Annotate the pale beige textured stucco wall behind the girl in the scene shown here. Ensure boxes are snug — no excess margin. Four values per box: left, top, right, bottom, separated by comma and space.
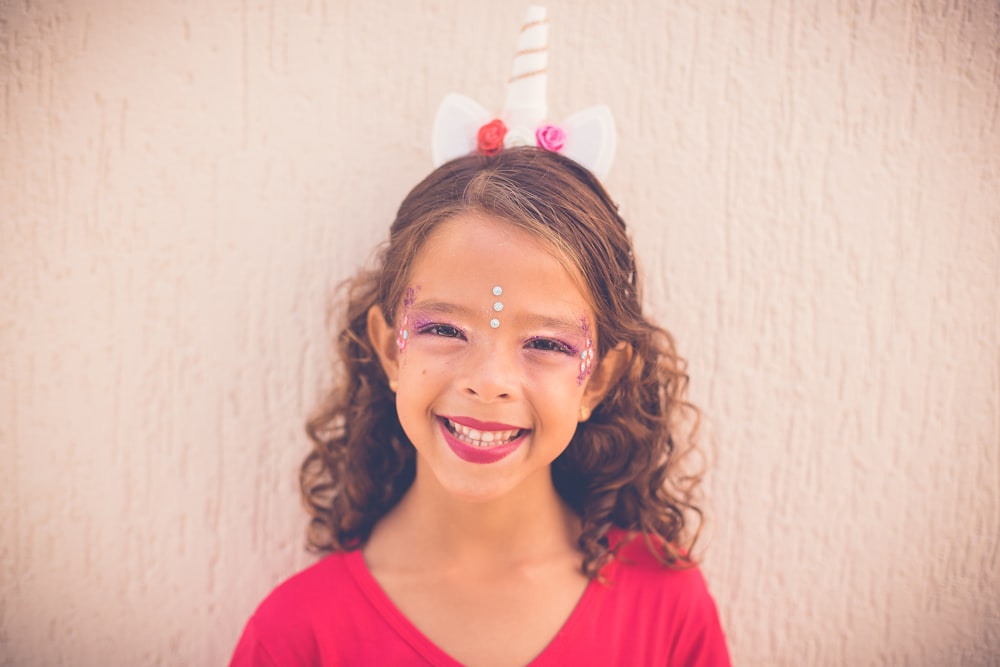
0, 0, 1000, 666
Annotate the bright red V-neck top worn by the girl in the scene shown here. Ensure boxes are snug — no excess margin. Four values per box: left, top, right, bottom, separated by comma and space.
230, 536, 729, 667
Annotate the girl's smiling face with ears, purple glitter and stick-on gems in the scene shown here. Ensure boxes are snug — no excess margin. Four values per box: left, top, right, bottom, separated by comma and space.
369, 213, 605, 500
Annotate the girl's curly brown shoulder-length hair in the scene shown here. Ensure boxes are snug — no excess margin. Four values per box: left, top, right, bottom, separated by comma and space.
299, 147, 702, 577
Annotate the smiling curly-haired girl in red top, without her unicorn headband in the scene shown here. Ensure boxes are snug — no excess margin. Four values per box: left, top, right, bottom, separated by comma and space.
232, 146, 729, 667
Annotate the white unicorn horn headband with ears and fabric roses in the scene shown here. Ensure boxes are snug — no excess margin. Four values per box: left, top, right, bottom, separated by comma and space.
431, 6, 615, 178
